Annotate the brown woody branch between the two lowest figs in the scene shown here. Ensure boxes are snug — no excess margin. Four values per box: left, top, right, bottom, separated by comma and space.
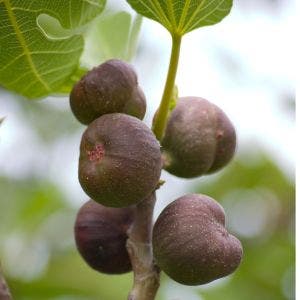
126, 192, 160, 300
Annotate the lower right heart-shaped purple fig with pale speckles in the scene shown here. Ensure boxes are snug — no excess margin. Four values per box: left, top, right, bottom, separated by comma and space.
153, 194, 243, 285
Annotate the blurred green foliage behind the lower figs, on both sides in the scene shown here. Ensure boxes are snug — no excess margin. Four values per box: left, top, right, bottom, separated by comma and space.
0, 153, 295, 300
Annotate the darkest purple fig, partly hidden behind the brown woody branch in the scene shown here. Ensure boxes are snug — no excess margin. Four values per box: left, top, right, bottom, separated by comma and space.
74, 200, 134, 274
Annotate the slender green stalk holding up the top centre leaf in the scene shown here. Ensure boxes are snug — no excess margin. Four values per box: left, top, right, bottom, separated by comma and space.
152, 34, 181, 141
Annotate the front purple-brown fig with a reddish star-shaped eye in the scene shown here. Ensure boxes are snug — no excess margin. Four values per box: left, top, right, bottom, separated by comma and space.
79, 113, 161, 207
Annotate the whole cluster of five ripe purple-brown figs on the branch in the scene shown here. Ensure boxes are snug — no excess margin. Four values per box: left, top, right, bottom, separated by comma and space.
70, 59, 243, 285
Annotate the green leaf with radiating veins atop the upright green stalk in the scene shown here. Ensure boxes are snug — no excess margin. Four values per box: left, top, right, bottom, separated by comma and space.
127, 0, 232, 36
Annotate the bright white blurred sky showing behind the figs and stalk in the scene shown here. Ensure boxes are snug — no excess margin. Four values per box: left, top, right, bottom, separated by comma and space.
0, 0, 296, 203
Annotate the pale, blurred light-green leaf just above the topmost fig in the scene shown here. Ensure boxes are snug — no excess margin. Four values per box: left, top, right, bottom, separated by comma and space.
82, 11, 142, 66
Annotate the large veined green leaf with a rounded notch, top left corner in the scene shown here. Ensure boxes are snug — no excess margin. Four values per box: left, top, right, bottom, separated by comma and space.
0, 0, 105, 98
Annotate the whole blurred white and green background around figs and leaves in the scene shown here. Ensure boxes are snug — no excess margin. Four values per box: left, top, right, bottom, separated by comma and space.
0, 0, 296, 300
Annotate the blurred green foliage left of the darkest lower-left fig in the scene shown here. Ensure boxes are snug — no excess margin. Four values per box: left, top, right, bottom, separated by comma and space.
0, 177, 131, 300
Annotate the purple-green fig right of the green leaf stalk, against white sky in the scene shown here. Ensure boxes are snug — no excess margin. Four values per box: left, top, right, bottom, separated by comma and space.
161, 97, 236, 178
